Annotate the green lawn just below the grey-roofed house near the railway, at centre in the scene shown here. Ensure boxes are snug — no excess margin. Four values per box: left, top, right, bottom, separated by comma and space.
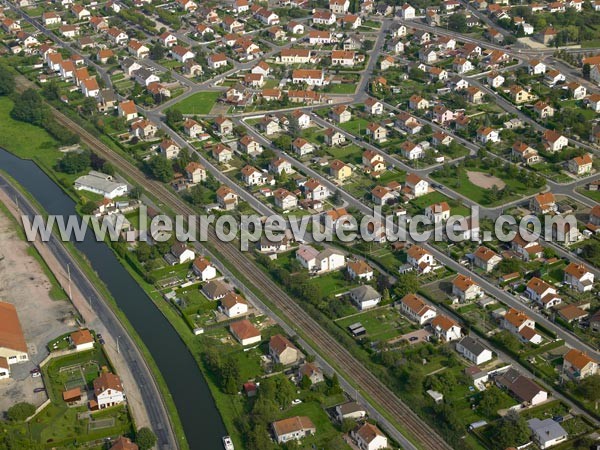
336, 306, 410, 341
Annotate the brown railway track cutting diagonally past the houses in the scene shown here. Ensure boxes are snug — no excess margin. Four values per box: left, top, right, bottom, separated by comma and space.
52, 109, 451, 450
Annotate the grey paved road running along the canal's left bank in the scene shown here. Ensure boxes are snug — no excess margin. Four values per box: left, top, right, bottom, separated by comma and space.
0, 175, 179, 450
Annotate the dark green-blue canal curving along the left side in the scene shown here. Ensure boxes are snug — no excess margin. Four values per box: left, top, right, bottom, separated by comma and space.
0, 149, 227, 450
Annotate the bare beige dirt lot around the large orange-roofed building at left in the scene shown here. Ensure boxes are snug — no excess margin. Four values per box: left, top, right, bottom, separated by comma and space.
0, 206, 76, 414
